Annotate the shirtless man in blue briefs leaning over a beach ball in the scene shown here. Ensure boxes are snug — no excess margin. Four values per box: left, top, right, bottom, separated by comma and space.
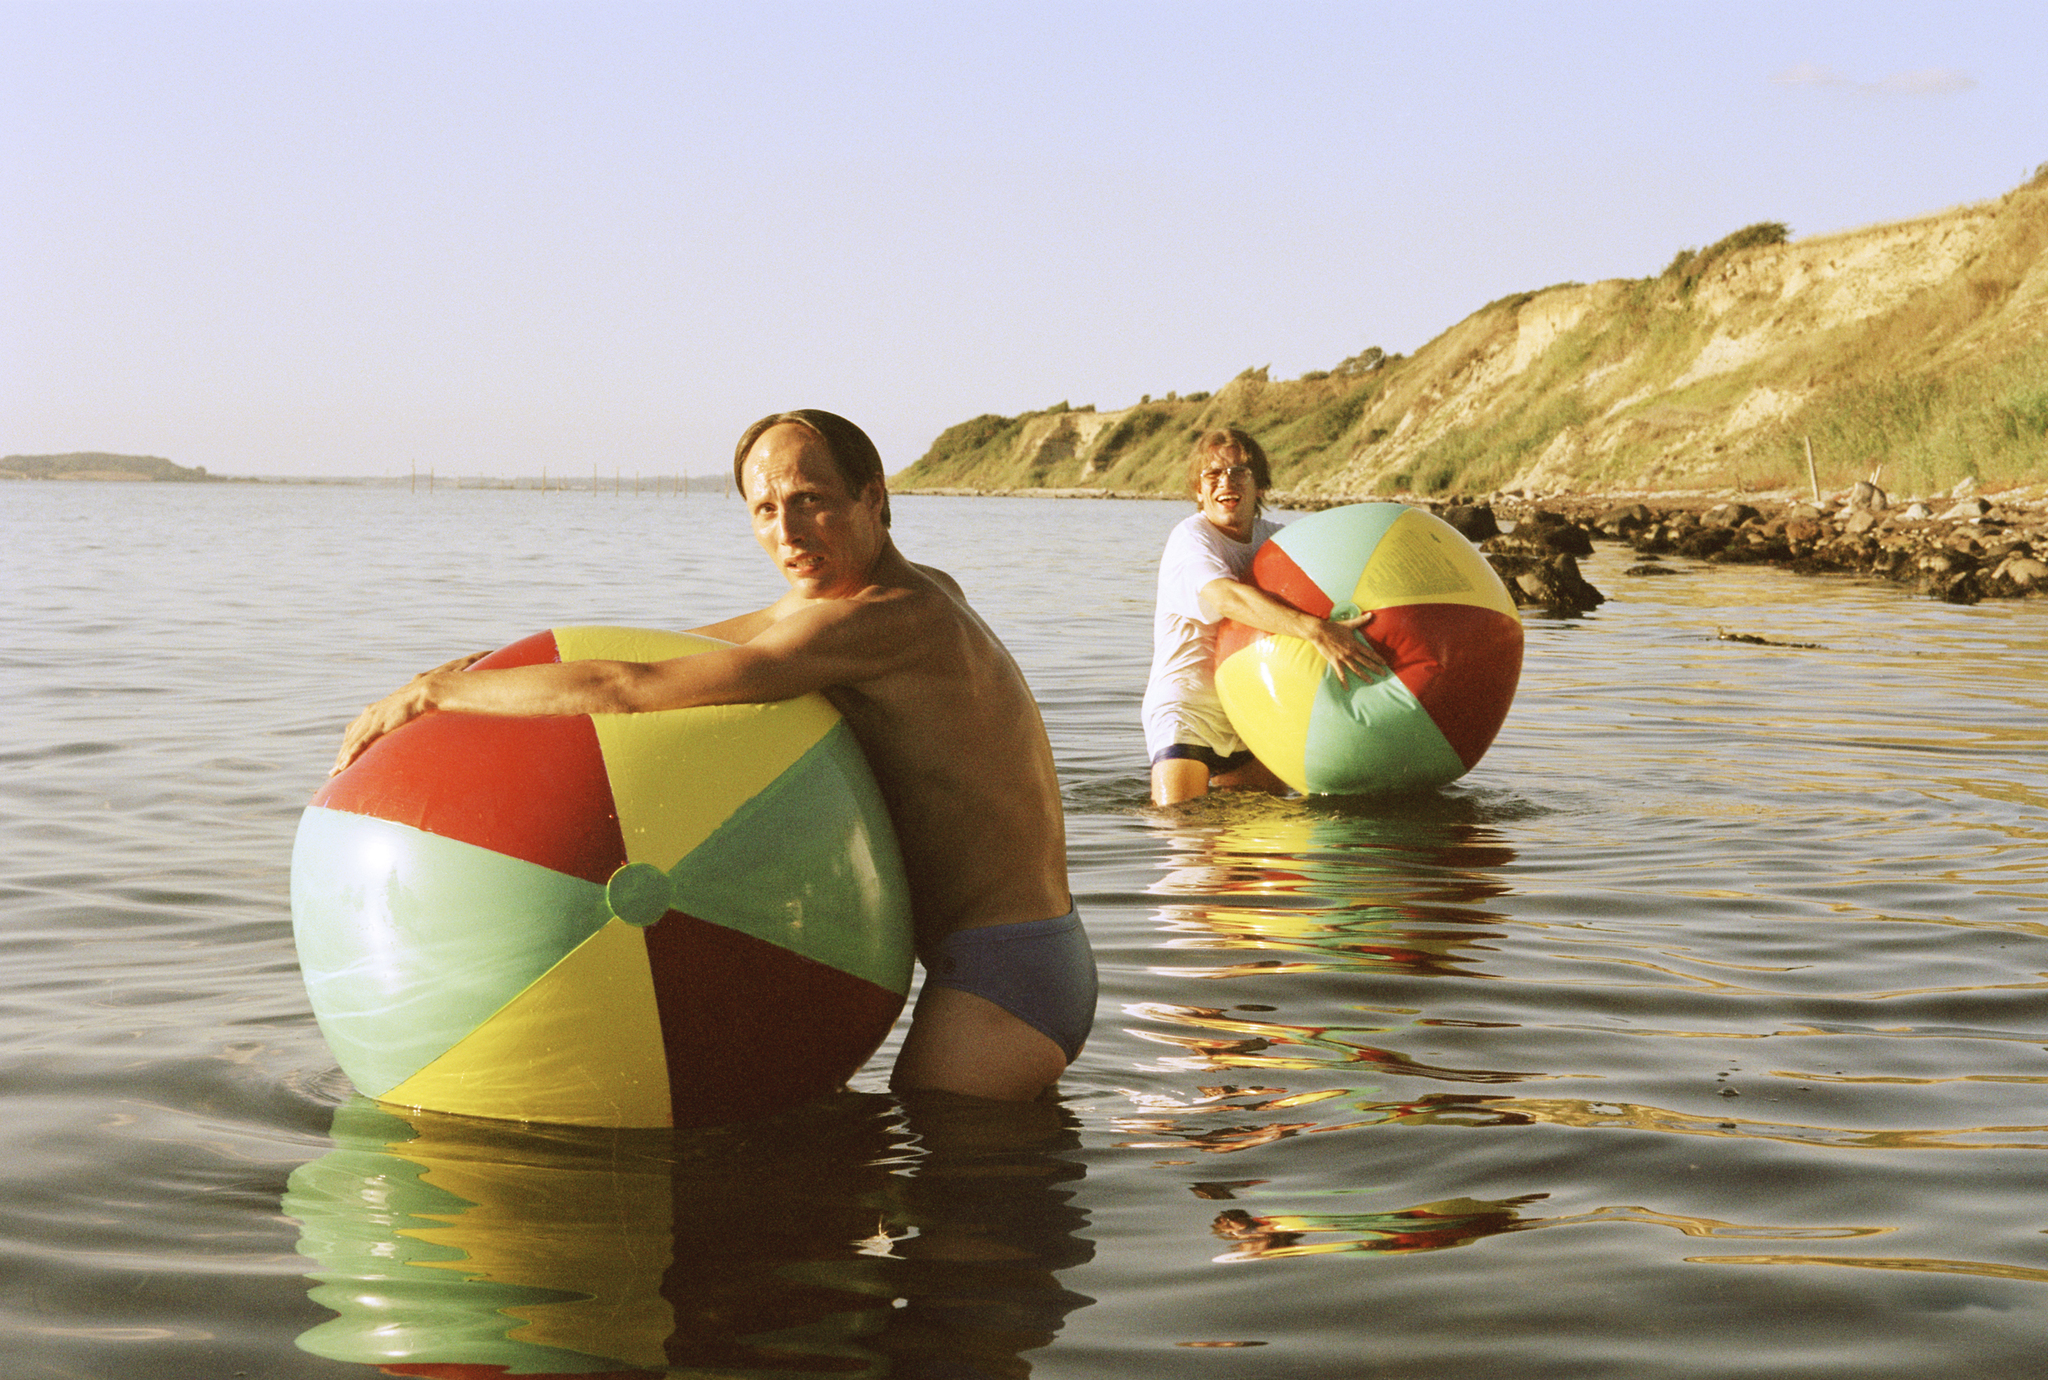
334, 409, 1096, 1102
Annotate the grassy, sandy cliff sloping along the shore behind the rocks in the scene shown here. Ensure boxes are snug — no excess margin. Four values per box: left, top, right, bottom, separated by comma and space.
895, 164, 2048, 498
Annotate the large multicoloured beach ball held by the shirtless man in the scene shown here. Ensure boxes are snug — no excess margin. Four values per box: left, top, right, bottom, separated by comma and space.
291, 629, 911, 1126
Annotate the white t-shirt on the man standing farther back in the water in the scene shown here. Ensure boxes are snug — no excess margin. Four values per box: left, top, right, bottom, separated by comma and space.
1145, 514, 1280, 758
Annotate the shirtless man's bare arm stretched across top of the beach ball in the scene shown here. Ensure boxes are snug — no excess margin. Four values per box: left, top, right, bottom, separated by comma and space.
334, 598, 918, 772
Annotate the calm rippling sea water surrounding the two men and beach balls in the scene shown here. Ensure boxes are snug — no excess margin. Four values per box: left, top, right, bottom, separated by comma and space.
0, 483, 2048, 1380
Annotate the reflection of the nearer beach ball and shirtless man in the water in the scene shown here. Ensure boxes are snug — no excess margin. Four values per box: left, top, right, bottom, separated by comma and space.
283, 1093, 1092, 1378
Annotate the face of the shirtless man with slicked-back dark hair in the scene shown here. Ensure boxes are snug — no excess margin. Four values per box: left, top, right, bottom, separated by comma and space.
739, 422, 887, 600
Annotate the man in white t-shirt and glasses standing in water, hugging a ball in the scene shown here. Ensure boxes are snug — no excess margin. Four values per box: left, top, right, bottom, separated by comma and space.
1145, 426, 1386, 805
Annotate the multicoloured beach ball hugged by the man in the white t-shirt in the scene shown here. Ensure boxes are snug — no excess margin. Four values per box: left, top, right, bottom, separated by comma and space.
1217, 504, 1522, 794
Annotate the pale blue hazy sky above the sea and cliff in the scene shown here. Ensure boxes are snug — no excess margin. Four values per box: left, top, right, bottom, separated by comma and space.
0, 0, 2048, 475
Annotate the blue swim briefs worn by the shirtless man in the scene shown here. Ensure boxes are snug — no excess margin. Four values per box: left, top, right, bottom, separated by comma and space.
920, 909, 1096, 1063
